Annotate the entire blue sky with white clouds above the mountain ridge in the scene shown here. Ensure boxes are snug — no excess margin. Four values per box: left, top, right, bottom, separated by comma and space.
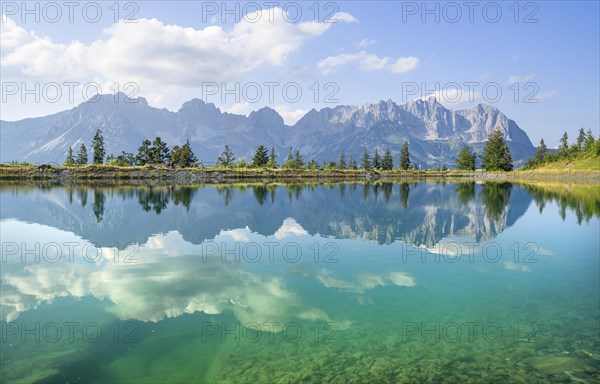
1, 1, 600, 146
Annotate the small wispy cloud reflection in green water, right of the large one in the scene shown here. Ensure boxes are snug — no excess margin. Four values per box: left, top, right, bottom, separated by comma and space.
315, 269, 416, 293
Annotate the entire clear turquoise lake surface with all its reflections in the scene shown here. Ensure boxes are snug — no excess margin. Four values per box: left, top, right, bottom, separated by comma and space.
0, 183, 600, 383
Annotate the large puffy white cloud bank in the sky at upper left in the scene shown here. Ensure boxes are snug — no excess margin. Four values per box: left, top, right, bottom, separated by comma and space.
1, 10, 356, 86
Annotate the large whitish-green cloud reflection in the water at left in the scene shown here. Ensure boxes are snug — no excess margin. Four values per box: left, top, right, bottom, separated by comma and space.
0, 232, 331, 323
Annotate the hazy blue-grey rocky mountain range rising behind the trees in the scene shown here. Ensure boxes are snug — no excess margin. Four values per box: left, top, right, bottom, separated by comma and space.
0, 94, 534, 167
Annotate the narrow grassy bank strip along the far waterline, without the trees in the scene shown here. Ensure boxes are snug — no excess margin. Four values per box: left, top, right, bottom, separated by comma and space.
0, 165, 600, 185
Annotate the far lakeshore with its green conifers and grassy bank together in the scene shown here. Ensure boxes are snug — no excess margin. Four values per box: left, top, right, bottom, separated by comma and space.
0, 125, 600, 183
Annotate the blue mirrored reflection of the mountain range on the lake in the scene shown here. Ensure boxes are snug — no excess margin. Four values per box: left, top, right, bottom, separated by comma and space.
1, 183, 532, 247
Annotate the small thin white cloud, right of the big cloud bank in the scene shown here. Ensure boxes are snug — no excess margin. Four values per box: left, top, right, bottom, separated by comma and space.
317, 51, 419, 75
